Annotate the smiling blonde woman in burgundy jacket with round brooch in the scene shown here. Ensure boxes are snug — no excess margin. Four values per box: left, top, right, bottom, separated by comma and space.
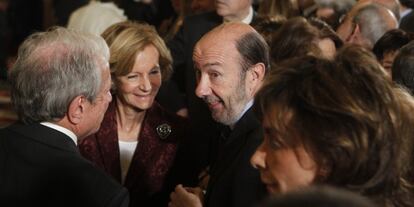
79, 22, 185, 206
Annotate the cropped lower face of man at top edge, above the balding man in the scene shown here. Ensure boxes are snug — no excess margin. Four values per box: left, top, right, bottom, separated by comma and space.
214, 0, 251, 19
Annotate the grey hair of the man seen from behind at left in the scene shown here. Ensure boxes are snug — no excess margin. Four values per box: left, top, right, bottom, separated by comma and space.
9, 27, 109, 123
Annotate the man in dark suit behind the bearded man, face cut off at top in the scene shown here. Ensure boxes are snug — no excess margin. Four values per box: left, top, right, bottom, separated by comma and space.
167, 0, 255, 187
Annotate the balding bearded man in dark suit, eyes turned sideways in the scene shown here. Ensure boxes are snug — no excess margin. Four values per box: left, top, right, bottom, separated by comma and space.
170, 23, 269, 207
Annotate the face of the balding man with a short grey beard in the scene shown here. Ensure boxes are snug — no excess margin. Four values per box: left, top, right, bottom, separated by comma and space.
193, 37, 251, 125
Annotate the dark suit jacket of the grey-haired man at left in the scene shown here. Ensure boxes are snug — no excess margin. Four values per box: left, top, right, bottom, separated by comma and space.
0, 123, 128, 207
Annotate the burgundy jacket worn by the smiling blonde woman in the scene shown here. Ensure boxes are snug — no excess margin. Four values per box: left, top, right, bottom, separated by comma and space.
79, 99, 186, 206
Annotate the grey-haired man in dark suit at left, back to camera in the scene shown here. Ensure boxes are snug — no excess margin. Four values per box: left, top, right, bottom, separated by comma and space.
0, 28, 129, 206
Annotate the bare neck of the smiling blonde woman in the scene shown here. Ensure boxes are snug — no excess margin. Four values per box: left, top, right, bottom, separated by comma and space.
116, 100, 146, 132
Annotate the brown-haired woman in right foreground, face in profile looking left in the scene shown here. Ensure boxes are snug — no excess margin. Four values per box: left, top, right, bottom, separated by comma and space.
251, 46, 414, 207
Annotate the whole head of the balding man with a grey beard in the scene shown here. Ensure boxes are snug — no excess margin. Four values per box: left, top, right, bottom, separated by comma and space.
193, 23, 269, 125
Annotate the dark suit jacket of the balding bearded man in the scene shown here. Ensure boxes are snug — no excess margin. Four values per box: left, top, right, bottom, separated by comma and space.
204, 109, 267, 207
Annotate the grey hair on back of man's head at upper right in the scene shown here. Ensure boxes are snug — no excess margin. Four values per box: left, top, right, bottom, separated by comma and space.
353, 3, 395, 47
